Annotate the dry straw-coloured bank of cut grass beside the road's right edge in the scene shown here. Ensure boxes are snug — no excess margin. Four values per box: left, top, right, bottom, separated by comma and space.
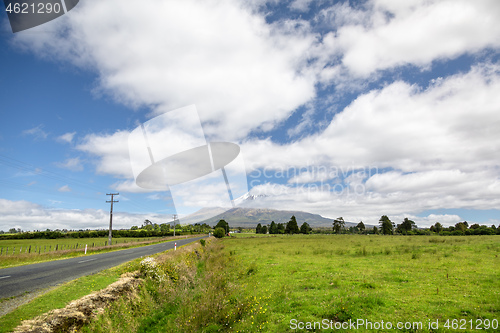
14, 272, 143, 333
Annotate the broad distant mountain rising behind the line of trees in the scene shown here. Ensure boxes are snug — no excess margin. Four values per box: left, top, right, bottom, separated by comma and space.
193, 208, 357, 228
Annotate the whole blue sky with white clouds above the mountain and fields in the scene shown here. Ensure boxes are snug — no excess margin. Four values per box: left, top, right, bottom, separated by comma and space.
0, 0, 500, 231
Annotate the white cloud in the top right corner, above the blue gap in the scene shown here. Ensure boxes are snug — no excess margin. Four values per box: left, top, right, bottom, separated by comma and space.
328, 0, 500, 76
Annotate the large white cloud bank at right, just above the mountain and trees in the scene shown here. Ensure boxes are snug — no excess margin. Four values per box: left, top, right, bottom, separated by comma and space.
243, 65, 500, 220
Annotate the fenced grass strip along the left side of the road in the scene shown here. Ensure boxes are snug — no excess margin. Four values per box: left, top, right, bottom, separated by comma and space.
0, 235, 194, 268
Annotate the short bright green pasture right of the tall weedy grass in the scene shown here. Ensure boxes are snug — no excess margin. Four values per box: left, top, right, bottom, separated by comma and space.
224, 235, 500, 332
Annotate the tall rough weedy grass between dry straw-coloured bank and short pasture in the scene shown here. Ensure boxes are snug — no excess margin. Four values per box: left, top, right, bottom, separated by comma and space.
81, 240, 257, 333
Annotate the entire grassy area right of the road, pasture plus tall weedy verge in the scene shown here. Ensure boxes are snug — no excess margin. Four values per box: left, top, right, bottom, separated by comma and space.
73, 235, 500, 332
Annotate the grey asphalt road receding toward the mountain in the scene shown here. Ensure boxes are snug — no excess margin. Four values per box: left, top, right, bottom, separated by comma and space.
0, 236, 208, 298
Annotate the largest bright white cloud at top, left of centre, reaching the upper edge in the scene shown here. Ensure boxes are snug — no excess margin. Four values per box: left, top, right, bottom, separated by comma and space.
16, 0, 316, 140
